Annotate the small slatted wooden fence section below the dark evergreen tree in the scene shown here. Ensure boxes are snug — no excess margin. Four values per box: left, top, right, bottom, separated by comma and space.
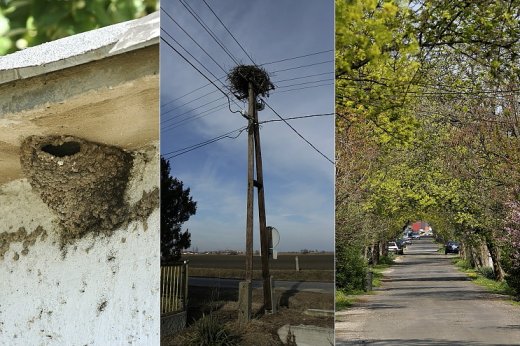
161, 261, 188, 315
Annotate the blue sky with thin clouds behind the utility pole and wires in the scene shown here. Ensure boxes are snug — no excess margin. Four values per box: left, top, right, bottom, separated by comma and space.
160, 0, 334, 251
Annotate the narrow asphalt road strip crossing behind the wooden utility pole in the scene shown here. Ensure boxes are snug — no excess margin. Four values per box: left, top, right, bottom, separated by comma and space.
188, 277, 334, 294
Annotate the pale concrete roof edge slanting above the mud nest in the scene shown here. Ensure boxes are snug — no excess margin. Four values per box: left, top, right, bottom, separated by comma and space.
0, 11, 160, 84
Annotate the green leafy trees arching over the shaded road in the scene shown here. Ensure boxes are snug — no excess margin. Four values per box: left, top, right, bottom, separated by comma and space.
336, 0, 520, 293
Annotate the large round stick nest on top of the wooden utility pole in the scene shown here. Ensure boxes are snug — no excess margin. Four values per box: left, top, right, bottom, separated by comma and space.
227, 65, 274, 100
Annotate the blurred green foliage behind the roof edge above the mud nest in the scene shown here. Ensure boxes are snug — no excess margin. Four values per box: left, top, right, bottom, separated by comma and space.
0, 0, 159, 55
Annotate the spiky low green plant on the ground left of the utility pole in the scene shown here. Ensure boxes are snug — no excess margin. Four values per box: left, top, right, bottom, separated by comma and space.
191, 313, 240, 346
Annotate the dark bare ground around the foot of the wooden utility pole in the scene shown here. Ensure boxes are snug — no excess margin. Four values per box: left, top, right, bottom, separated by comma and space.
161, 287, 334, 346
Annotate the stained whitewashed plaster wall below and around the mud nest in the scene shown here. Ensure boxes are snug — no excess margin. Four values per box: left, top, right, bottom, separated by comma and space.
0, 143, 160, 345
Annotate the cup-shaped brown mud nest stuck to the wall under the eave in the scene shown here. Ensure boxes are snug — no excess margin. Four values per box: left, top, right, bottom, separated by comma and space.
20, 136, 132, 244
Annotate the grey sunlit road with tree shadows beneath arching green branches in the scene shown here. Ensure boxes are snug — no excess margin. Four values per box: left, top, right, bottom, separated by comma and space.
335, 239, 520, 346
